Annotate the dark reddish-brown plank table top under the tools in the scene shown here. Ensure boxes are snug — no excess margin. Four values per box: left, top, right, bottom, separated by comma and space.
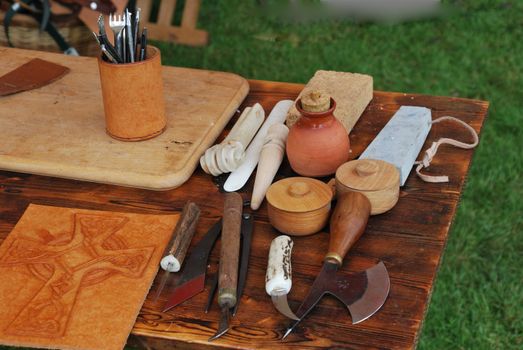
0, 80, 488, 349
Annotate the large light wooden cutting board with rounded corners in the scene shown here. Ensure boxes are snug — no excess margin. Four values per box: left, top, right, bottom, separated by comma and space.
0, 48, 249, 190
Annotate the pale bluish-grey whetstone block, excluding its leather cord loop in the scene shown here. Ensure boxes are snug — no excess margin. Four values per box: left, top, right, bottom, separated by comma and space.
359, 106, 432, 186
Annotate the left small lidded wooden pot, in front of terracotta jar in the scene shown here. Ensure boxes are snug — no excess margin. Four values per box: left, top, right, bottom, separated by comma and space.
266, 177, 333, 236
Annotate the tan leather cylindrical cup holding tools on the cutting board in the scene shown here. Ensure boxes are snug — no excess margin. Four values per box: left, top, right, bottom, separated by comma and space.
98, 46, 166, 141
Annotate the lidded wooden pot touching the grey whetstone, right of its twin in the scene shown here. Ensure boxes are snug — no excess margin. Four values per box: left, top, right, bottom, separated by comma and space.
336, 159, 400, 215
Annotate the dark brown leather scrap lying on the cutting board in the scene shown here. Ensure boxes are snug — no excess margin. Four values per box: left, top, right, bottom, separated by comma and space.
0, 58, 69, 96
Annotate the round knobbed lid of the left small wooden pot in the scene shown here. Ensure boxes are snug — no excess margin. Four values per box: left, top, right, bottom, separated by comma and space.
266, 177, 333, 213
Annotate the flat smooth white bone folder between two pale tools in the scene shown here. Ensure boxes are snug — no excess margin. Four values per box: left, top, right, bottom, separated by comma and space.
223, 100, 294, 192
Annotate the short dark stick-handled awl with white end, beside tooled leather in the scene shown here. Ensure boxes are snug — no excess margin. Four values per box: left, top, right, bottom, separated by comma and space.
155, 202, 200, 300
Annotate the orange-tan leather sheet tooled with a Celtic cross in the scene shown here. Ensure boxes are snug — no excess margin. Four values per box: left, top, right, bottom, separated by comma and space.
0, 205, 179, 349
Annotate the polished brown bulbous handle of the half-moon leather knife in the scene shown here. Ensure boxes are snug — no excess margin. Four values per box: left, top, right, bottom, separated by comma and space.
325, 191, 370, 265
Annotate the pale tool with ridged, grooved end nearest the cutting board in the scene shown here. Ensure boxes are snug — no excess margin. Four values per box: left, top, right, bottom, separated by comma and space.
200, 103, 265, 176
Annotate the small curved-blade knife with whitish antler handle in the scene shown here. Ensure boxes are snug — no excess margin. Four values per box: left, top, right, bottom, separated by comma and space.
265, 235, 299, 320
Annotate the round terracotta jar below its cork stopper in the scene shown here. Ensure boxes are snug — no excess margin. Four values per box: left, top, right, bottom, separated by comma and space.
286, 98, 350, 177
